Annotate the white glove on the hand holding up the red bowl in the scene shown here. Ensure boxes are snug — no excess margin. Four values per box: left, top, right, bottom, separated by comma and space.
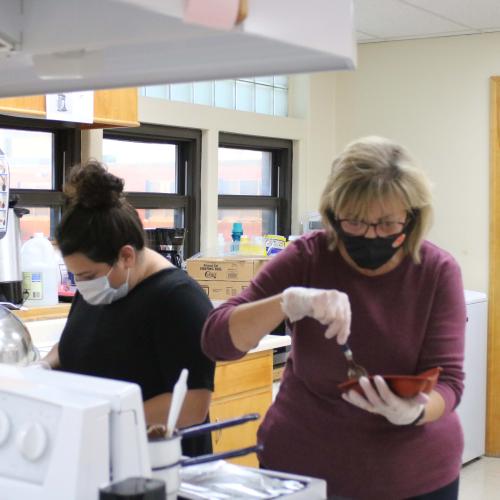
342, 375, 429, 425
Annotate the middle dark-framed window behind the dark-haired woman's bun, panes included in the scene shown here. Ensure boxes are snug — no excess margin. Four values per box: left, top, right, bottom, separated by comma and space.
103, 125, 201, 258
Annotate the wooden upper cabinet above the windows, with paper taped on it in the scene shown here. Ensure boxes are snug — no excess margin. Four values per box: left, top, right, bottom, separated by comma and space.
0, 88, 140, 128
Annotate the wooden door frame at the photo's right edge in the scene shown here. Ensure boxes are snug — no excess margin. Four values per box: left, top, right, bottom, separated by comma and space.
486, 76, 500, 456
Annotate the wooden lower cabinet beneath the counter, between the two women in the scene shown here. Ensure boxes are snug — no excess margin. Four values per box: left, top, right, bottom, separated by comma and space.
210, 349, 273, 467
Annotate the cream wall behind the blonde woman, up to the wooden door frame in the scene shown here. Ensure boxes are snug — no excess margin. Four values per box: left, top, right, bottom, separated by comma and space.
335, 34, 500, 292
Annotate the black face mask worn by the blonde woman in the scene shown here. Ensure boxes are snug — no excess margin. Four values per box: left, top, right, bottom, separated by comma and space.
327, 208, 415, 270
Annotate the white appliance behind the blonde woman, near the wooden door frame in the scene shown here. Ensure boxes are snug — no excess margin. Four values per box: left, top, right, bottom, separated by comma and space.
457, 290, 488, 463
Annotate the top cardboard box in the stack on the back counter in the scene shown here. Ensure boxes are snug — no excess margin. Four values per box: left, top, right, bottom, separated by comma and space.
186, 257, 269, 281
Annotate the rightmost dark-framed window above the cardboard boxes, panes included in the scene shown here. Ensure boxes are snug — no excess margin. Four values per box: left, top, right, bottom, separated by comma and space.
217, 133, 292, 241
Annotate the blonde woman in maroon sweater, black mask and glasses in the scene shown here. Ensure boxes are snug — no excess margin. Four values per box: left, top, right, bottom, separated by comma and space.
202, 137, 465, 500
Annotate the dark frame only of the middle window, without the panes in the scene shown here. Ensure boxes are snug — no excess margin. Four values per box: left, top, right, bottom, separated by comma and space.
103, 123, 201, 259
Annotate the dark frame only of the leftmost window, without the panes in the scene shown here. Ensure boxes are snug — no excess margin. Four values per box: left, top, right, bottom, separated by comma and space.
0, 115, 81, 237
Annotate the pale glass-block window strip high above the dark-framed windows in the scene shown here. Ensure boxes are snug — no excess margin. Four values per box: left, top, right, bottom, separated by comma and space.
141, 76, 288, 116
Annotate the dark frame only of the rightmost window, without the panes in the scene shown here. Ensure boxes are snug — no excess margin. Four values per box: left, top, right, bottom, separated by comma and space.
218, 132, 293, 238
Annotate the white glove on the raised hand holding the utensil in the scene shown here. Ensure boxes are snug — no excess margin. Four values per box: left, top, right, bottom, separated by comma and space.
281, 286, 351, 344
